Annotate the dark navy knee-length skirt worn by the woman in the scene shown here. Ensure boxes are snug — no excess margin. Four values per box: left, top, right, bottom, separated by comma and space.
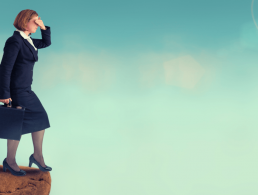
5, 86, 50, 135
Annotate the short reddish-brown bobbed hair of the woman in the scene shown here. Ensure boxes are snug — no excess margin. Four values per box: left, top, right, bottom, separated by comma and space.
13, 9, 38, 34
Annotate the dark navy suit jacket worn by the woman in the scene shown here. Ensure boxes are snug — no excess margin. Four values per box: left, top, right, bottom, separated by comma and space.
0, 26, 51, 99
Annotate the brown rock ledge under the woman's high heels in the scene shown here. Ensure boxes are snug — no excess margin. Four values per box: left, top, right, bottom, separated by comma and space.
0, 165, 51, 195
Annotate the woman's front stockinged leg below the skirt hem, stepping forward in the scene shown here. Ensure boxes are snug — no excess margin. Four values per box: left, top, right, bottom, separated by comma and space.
31, 129, 46, 167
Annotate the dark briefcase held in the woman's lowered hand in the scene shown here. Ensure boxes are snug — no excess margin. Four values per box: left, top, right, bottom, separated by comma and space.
0, 101, 26, 141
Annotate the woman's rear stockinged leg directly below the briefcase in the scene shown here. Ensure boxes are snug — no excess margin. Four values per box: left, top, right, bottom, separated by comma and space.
6, 136, 20, 171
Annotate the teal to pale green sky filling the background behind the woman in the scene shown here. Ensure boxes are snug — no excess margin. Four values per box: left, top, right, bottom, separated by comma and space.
0, 0, 258, 195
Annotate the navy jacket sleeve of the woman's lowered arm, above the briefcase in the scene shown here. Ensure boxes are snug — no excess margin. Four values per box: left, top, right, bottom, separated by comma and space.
0, 37, 20, 99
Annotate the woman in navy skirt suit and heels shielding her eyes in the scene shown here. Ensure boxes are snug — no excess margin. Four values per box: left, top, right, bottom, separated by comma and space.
0, 9, 52, 176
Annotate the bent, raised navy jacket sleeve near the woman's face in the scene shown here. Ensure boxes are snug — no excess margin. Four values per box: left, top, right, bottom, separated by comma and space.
31, 26, 51, 49
